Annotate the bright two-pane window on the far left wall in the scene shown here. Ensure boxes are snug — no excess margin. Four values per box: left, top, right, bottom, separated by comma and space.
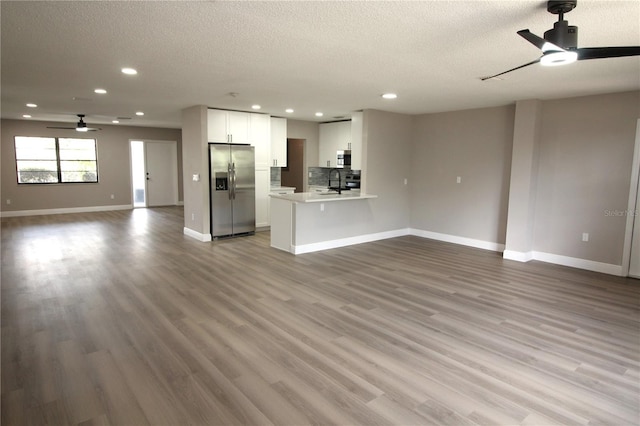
15, 136, 98, 183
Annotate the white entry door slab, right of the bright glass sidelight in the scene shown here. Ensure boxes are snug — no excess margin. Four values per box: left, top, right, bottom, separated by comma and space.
145, 141, 178, 207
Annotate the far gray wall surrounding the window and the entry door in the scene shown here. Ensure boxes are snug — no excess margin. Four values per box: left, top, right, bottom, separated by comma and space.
0, 120, 183, 212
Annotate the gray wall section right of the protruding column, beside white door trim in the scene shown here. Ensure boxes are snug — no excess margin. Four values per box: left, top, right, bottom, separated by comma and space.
534, 92, 640, 265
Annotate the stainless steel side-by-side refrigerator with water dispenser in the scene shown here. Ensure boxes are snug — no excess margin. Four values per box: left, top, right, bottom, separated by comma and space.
209, 144, 256, 238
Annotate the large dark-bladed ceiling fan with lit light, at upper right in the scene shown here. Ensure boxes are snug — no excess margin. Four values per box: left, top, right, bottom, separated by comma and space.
480, 0, 640, 81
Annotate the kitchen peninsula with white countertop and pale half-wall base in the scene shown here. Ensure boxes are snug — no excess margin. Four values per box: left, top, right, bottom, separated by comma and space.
271, 191, 377, 254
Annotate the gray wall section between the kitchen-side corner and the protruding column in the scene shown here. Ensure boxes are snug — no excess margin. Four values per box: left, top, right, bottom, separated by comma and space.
410, 106, 515, 244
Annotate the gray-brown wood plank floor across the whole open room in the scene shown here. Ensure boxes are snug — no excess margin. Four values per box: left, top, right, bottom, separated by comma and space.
1, 207, 640, 425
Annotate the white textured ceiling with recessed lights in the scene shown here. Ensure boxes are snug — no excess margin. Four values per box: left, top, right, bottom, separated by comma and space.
0, 0, 640, 128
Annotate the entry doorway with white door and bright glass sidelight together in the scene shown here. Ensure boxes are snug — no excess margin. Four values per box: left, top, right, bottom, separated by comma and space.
130, 140, 178, 208
